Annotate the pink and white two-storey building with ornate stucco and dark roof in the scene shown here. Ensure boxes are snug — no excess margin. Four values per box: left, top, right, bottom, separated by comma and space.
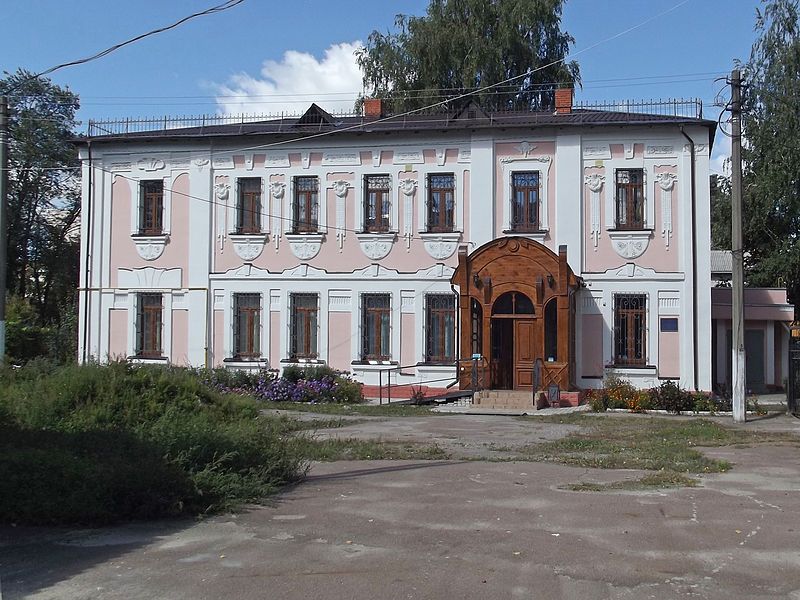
79, 96, 732, 390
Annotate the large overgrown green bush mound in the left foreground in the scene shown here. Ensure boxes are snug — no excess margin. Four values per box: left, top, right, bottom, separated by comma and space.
0, 361, 305, 523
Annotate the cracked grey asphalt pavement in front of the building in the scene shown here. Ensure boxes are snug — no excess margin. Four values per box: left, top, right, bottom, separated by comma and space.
0, 416, 800, 600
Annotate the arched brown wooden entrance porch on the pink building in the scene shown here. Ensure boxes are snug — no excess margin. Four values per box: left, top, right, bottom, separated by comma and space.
451, 237, 579, 390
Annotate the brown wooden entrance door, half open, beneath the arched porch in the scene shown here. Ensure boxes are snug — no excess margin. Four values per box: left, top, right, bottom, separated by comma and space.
491, 316, 540, 390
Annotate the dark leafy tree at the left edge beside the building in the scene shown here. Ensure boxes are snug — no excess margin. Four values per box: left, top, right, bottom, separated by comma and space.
0, 69, 80, 323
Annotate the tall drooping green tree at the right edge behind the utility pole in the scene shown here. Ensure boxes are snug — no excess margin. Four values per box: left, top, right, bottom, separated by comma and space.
742, 0, 800, 306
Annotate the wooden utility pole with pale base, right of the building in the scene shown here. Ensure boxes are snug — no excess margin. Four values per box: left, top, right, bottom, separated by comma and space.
731, 69, 746, 423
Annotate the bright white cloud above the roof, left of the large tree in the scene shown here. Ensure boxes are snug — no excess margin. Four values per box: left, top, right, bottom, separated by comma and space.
215, 41, 361, 115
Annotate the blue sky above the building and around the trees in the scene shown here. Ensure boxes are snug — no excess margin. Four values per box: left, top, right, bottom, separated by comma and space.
0, 0, 761, 166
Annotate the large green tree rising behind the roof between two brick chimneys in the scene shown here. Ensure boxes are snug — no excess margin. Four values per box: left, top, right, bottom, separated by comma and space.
357, 0, 580, 111
